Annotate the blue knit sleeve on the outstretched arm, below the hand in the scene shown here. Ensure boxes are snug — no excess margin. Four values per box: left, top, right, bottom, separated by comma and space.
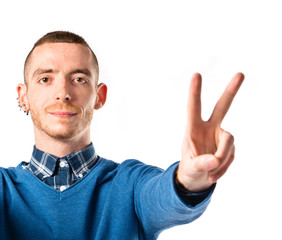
134, 162, 214, 239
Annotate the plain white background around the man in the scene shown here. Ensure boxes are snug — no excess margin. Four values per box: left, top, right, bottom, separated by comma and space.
0, 0, 282, 240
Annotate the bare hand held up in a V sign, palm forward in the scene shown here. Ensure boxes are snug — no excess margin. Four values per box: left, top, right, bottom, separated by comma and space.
177, 73, 244, 192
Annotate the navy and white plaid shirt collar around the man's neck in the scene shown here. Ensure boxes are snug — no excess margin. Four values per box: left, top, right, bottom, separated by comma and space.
26, 143, 97, 180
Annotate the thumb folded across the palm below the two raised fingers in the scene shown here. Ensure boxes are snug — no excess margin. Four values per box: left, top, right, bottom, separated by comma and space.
192, 154, 220, 173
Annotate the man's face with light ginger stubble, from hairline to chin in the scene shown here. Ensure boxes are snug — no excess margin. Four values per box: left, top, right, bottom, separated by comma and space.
23, 43, 102, 139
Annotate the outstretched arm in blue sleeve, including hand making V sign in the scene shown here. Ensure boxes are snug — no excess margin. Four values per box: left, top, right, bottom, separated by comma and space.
135, 73, 244, 237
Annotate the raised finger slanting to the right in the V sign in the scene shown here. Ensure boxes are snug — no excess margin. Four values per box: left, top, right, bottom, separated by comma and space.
210, 73, 245, 123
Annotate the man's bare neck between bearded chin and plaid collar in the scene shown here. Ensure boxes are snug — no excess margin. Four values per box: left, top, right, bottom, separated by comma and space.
34, 127, 90, 158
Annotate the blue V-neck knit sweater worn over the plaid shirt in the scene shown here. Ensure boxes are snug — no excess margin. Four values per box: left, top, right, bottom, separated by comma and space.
0, 158, 211, 240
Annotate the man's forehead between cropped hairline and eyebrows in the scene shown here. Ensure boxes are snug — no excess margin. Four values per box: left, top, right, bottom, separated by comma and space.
28, 43, 96, 77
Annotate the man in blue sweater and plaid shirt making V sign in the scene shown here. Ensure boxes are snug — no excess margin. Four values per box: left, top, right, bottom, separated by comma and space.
0, 32, 244, 240
